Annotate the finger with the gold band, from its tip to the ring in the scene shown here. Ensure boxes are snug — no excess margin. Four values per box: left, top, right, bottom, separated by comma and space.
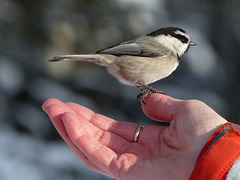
66, 103, 139, 142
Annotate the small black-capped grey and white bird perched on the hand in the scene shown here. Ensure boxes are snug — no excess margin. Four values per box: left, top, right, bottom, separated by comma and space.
49, 27, 196, 103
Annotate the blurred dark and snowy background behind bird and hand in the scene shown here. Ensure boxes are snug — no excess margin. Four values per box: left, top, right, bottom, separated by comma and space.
0, 0, 240, 180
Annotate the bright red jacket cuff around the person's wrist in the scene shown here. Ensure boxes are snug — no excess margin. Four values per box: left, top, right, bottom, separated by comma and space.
189, 122, 240, 180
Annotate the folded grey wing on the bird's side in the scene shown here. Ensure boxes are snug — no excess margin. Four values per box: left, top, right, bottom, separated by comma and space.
96, 41, 167, 57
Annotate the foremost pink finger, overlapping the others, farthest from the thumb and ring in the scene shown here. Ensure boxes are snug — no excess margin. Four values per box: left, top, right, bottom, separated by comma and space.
62, 113, 117, 174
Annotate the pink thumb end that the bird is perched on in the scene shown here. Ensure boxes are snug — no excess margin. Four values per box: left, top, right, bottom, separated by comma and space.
142, 93, 182, 122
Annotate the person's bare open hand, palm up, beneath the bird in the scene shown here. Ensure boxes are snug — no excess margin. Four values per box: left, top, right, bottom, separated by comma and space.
43, 93, 227, 180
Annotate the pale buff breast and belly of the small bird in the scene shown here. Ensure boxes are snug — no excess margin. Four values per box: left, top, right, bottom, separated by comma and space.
108, 54, 179, 86
